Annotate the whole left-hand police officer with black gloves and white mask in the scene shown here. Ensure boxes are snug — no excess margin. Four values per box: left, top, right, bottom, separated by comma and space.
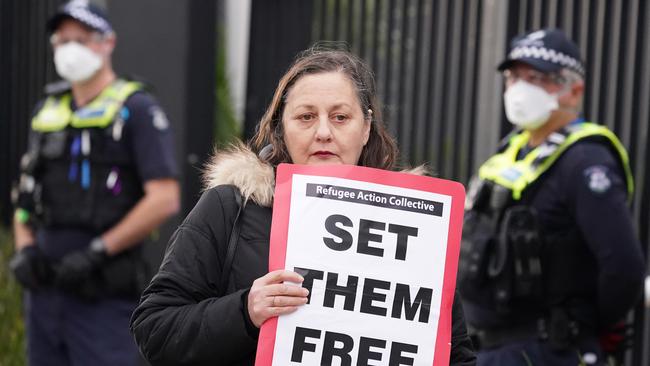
10, 1, 179, 365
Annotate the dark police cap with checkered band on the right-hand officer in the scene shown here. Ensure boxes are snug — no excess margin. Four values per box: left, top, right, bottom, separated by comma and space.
498, 29, 585, 76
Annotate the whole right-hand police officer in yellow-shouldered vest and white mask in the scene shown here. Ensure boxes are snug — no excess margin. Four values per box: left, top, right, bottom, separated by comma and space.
459, 29, 645, 366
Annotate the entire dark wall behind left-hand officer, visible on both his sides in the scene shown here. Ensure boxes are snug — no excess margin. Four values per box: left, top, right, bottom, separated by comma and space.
0, 0, 217, 300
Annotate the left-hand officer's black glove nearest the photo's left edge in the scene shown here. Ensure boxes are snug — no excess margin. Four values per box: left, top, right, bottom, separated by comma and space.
9, 245, 53, 290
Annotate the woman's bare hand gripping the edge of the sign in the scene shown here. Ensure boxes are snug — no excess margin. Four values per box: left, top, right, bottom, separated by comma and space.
248, 269, 309, 328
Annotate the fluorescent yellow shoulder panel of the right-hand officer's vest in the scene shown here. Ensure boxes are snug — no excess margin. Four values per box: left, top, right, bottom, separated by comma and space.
479, 122, 634, 200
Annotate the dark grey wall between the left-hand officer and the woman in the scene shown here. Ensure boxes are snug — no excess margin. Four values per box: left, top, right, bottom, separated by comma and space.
108, 0, 217, 217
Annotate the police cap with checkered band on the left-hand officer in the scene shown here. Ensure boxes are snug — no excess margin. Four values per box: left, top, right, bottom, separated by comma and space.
47, 0, 113, 34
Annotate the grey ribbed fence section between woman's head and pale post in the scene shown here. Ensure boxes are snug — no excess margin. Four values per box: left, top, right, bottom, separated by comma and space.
313, 0, 482, 181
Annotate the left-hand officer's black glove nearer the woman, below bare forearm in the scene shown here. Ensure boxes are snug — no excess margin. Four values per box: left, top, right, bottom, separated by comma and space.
54, 239, 108, 292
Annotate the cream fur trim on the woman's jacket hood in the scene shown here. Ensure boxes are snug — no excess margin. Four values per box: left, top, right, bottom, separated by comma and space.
203, 144, 428, 207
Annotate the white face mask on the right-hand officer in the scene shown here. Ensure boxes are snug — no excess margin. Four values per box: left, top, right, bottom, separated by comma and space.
503, 80, 559, 130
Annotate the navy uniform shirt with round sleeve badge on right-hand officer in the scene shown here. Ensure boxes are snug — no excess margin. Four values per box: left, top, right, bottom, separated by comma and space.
522, 141, 645, 328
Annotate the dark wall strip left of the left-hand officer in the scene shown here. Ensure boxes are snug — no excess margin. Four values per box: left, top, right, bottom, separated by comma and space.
0, 0, 63, 224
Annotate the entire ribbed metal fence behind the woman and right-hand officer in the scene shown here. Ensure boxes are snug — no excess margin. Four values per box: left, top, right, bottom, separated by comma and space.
246, 0, 650, 365
